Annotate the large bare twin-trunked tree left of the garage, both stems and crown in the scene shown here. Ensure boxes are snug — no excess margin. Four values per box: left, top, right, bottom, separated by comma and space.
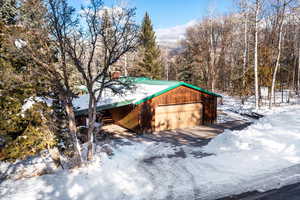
18, 0, 138, 162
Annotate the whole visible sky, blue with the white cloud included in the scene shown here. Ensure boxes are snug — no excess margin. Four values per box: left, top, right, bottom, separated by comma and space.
71, 0, 234, 46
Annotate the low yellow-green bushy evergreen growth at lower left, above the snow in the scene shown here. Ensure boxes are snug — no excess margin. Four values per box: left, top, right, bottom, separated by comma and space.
0, 103, 57, 161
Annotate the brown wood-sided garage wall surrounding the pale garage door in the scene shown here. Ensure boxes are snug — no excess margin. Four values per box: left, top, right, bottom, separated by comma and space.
109, 86, 217, 133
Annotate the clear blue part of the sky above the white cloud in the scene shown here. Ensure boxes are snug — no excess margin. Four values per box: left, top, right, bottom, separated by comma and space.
71, 0, 233, 29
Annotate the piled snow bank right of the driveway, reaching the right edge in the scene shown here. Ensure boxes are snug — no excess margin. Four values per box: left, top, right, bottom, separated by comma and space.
203, 107, 300, 173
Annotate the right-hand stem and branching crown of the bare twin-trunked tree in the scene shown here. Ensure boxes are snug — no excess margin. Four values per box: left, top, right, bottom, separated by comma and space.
53, 0, 138, 160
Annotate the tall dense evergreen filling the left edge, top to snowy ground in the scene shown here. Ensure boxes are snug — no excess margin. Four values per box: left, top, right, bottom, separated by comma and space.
0, 1, 57, 160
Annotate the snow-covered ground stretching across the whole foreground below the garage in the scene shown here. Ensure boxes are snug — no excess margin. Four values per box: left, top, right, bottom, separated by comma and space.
0, 94, 300, 200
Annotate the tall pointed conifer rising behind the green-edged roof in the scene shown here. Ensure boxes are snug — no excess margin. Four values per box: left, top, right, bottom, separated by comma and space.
137, 13, 163, 79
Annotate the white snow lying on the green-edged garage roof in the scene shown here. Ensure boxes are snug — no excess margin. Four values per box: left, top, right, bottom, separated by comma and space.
73, 83, 170, 114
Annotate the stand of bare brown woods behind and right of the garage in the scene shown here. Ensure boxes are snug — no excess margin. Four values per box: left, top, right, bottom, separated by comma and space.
165, 0, 300, 108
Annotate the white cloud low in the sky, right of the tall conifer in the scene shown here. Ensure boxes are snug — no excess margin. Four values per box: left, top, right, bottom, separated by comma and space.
156, 20, 197, 47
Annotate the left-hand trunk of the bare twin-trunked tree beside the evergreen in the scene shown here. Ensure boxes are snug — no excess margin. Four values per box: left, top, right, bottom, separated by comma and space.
65, 100, 82, 167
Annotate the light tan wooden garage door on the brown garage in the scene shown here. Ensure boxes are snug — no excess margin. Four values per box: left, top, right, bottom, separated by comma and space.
155, 103, 203, 131
